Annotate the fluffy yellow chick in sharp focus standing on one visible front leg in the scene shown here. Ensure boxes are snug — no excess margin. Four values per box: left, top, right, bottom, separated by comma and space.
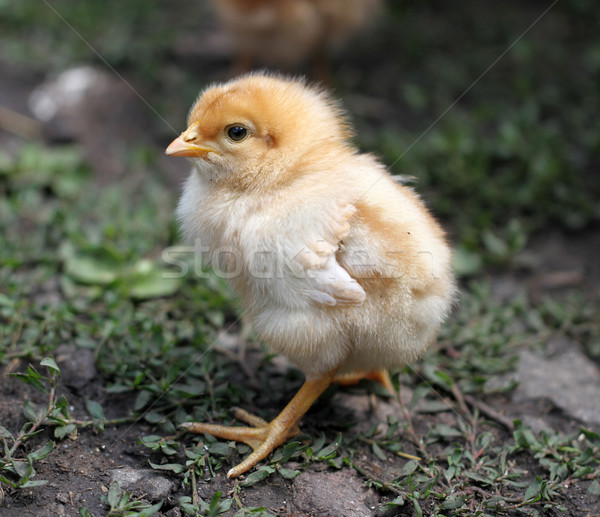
166, 74, 454, 477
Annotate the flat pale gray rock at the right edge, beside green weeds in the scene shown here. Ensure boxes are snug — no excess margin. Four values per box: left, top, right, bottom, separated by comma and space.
513, 345, 600, 425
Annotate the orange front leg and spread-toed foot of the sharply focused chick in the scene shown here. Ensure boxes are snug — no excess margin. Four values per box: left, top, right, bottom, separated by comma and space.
182, 371, 335, 478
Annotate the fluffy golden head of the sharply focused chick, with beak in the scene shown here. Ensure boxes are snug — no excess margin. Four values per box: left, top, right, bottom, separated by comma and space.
166, 74, 351, 189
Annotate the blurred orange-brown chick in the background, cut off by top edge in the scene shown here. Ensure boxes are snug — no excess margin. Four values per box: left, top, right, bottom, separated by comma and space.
213, 0, 381, 79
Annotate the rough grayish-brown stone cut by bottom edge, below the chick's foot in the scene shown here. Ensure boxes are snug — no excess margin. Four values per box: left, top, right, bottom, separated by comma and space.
292, 469, 375, 517
